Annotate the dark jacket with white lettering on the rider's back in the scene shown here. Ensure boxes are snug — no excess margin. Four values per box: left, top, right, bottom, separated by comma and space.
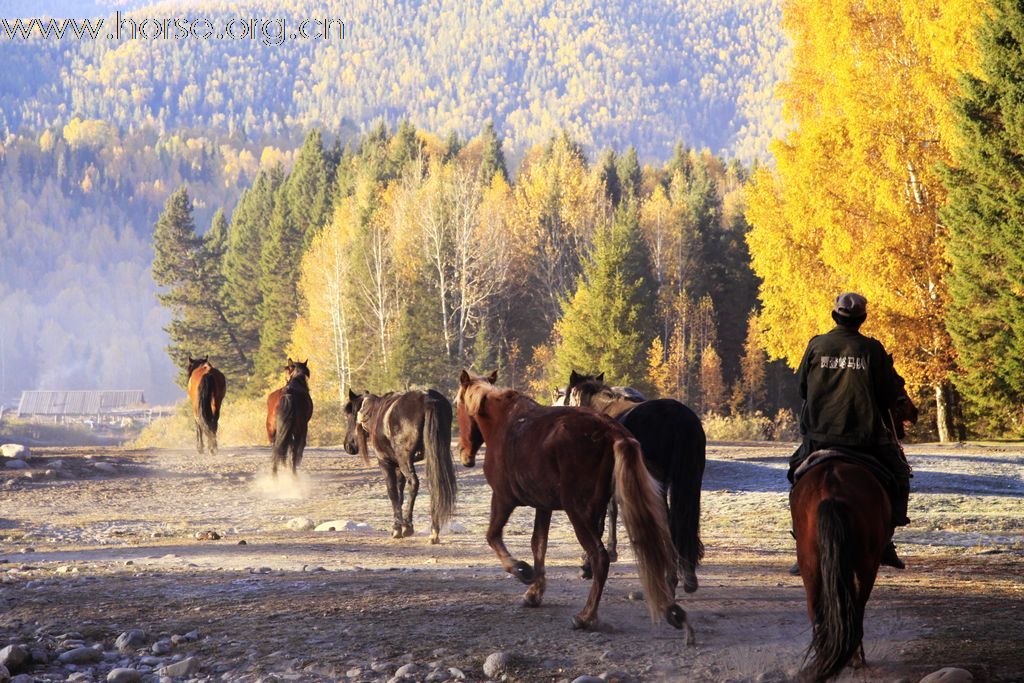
797, 326, 903, 446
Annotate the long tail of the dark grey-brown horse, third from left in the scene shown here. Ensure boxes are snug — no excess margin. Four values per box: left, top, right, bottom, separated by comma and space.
423, 391, 456, 540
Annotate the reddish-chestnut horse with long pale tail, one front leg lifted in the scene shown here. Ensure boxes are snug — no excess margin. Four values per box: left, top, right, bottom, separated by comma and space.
457, 371, 693, 643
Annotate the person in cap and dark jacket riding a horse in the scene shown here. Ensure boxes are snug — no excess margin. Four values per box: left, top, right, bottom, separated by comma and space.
787, 292, 910, 573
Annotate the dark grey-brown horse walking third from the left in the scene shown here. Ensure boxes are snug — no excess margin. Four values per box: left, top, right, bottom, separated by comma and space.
345, 389, 456, 543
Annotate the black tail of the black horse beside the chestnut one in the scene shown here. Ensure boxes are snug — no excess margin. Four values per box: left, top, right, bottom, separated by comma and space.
668, 405, 708, 593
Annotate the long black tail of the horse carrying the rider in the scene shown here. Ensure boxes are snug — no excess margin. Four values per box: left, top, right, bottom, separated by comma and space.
806, 499, 864, 681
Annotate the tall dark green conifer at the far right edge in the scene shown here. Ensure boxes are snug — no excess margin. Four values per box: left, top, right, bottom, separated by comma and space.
942, 0, 1024, 432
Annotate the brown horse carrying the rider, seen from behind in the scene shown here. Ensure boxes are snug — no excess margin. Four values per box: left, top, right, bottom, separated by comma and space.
790, 391, 918, 681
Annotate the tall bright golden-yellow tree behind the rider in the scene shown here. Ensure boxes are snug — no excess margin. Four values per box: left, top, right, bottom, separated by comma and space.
746, 0, 982, 401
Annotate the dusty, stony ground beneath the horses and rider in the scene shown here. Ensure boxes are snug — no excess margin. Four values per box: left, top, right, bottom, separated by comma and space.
0, 443, 1024, 683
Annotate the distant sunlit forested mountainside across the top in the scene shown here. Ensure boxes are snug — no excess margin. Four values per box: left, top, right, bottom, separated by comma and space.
0, 0, 786, 161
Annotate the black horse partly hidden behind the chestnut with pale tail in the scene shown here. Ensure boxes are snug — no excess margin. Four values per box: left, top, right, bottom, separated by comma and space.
565, 371, 707, 593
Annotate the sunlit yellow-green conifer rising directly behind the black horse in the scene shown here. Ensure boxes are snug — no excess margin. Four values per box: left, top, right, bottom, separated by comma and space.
552, 212, 654, 391
